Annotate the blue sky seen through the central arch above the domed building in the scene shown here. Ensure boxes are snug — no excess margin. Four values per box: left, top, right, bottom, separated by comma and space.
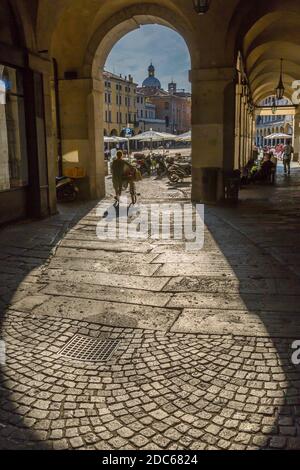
105, 25, 191, 91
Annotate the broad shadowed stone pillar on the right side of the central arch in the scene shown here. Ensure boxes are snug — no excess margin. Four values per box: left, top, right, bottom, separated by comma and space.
191, 67, 236, 203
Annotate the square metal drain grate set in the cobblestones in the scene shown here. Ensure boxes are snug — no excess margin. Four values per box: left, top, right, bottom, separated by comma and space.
59, 335, 120, 362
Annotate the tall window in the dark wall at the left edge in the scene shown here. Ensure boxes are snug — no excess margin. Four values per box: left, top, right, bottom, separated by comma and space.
0, 64, 28, 191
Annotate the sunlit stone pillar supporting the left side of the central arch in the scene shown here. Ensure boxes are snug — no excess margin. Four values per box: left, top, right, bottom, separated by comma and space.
59, 78, 105, 199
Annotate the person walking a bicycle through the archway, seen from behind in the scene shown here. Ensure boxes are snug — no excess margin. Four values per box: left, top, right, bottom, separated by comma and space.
111, 150, 141, 202
